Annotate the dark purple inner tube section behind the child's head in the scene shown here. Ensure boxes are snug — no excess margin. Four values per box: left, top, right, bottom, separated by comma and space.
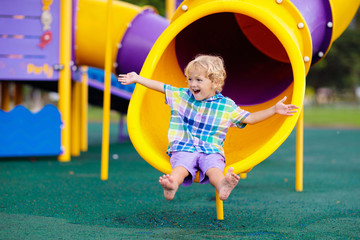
175, 13, 293, 106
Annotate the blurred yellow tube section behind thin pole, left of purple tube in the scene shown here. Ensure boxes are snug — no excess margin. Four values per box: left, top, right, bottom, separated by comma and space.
74, 0, 153, 68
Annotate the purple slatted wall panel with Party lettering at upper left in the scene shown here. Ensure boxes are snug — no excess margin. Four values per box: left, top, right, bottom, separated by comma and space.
0, 0, 60, 81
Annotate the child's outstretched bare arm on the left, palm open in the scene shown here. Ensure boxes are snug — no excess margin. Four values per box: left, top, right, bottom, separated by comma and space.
118, 72, 164, 93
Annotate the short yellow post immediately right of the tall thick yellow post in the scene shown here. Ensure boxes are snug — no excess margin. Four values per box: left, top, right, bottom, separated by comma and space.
71, 81, 81, 156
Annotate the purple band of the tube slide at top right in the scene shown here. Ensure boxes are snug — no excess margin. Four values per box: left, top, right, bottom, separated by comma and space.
291, 0, 333, 64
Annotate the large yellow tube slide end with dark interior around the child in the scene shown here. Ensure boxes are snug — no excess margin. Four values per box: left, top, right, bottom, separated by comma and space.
128, 0, 360, 176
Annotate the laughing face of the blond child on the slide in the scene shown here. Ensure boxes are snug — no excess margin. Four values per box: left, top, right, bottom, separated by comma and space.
187, 68, 216, 101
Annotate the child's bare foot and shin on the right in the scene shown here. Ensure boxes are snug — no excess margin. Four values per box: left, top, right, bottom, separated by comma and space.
206, 167, 240, 200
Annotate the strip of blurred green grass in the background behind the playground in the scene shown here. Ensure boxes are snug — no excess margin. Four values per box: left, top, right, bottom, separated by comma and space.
88, 105, 360, 128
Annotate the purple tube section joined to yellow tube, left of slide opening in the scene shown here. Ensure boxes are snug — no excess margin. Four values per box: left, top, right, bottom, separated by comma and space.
117, 9, 169, 73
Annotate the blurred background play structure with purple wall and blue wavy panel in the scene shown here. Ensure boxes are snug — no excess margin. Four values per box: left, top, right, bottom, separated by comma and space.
0, 0, 168, 161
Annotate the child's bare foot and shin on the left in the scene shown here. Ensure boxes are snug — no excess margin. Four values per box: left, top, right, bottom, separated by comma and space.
159, 166, 189, 200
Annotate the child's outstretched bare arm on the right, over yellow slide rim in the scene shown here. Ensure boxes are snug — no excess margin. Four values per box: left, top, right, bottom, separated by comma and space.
243, 96, 298, 124
